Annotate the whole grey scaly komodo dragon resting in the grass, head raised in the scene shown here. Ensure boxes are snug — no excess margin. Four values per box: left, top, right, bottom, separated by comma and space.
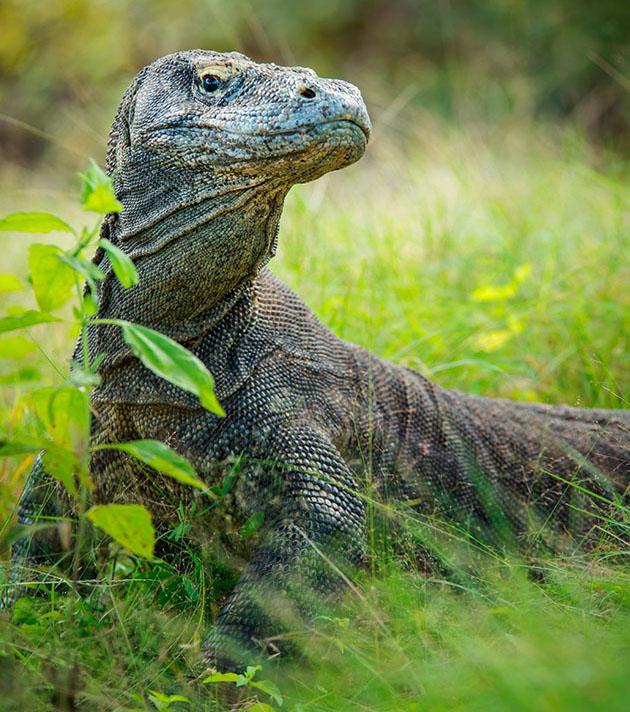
6, 50, 630, 667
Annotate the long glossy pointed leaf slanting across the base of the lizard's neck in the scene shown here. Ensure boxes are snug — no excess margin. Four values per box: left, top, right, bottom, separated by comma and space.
115, 320, 225, 416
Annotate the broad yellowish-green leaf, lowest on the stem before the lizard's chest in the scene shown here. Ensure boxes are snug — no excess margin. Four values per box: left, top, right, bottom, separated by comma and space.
87, 504, 155, 559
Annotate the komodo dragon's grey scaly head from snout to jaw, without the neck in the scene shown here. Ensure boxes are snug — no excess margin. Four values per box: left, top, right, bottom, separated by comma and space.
108, 50, 370, 195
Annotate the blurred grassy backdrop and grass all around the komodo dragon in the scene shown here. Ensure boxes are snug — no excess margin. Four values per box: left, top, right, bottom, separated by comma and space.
0, 0, 630, 711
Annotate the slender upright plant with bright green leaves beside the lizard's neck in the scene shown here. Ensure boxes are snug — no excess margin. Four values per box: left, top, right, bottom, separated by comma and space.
0, 161, 224, 559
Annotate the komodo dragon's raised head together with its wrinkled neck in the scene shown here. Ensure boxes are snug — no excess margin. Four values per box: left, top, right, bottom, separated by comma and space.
103, 50, 370, 322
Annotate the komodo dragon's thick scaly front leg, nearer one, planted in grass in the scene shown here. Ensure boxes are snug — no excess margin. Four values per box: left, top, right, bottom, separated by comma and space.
204, 431, 365, 669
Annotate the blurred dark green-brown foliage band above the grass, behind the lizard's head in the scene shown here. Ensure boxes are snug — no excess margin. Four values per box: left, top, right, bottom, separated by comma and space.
0, 0, 630, 171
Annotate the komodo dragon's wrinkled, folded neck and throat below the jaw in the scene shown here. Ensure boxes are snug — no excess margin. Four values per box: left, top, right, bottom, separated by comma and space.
99, 181, 286, 340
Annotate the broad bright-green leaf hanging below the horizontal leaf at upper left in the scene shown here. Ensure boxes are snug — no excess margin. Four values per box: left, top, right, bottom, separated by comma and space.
28, 245, 76, 311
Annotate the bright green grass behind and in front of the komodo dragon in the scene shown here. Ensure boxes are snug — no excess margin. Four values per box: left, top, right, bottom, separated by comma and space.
0, 114, 630, 712
